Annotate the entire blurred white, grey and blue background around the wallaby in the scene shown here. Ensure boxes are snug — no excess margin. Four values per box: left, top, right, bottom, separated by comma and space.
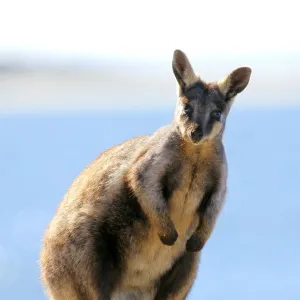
0, 0, 300, 300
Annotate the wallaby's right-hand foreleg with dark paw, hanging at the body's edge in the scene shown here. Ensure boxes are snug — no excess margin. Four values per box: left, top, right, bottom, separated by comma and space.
186, 188, 226, 252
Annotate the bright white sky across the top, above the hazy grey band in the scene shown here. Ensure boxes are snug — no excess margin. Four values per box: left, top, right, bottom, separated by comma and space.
0, 0, 300, 59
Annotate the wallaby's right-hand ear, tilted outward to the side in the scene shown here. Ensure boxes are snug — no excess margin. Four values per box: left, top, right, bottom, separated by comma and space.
218, 67, 251, 101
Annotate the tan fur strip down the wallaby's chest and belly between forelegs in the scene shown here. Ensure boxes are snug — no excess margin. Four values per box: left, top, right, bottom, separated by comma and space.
116, 157, 212, 299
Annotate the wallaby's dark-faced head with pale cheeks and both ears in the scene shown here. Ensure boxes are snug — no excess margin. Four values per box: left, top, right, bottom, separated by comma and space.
172, 50, 251, 145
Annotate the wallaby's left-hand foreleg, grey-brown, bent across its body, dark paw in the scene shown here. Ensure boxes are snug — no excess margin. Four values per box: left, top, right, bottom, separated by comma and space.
129, 157, 178, 246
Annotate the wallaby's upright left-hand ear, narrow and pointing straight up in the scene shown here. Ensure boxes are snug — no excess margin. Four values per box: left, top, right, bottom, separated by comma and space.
172, 50, 199, 89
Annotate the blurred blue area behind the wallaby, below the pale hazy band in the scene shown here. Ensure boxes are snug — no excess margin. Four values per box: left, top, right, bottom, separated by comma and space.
0, 108, 300, 300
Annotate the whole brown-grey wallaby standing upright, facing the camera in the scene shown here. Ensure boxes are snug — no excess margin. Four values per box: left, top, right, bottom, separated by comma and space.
40, 50, 251, 300
